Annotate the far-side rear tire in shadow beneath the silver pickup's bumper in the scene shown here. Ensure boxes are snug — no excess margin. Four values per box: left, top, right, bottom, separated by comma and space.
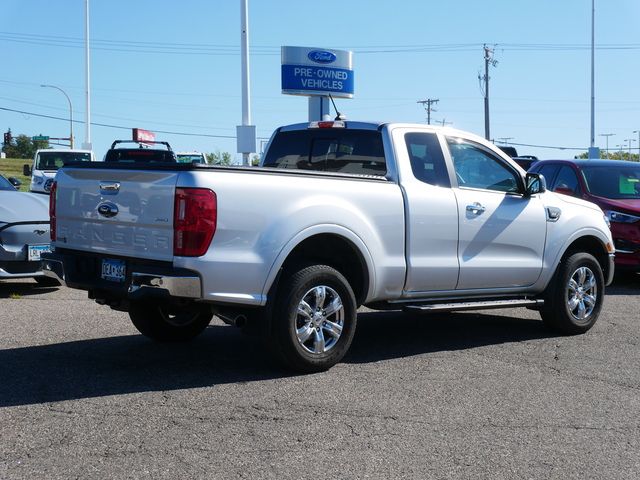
129, 302, 213, 342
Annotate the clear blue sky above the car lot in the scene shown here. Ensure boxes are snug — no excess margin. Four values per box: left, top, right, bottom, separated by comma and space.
0, 0, 640, 162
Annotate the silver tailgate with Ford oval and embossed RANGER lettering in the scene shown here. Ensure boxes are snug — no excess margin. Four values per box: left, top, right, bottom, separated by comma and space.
54, 168, 178, 261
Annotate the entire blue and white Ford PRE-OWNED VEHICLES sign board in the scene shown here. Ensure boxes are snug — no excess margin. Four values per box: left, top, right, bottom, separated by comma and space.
282, 47, 354, 98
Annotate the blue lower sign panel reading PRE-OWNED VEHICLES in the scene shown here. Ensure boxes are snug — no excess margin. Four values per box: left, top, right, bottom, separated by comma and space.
282, 65, 353, 96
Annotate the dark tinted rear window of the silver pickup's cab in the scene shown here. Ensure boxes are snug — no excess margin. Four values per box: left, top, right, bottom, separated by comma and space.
263, 128, 387, 176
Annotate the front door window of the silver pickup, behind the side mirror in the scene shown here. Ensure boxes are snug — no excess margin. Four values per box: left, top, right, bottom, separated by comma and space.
447, 138, 519, 192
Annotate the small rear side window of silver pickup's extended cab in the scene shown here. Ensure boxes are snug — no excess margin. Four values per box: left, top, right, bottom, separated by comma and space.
404, 132, 451, 187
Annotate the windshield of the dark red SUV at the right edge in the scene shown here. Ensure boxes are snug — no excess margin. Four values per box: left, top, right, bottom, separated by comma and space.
582, 164, 640, 200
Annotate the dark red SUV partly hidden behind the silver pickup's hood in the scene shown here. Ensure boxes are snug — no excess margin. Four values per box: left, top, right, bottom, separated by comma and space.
530, 160, 640, 271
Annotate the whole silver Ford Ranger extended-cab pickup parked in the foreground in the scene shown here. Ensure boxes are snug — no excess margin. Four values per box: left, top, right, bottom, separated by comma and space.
43, 121, 614, 372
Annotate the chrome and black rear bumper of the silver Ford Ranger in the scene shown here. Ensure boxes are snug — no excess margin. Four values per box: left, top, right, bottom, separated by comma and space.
42, 251, 202, 300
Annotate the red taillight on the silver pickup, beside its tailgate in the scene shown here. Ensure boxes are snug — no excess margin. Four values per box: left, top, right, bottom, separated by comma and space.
173, 188, 218, 257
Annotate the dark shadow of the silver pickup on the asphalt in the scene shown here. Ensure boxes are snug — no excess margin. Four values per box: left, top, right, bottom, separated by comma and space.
0, 312, 550, 407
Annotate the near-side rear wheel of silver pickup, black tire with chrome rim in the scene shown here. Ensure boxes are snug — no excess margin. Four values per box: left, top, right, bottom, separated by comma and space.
269, 265, 357, 373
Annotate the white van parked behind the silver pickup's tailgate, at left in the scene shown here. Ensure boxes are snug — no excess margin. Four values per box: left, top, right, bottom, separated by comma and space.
24, 148, 95, 194
